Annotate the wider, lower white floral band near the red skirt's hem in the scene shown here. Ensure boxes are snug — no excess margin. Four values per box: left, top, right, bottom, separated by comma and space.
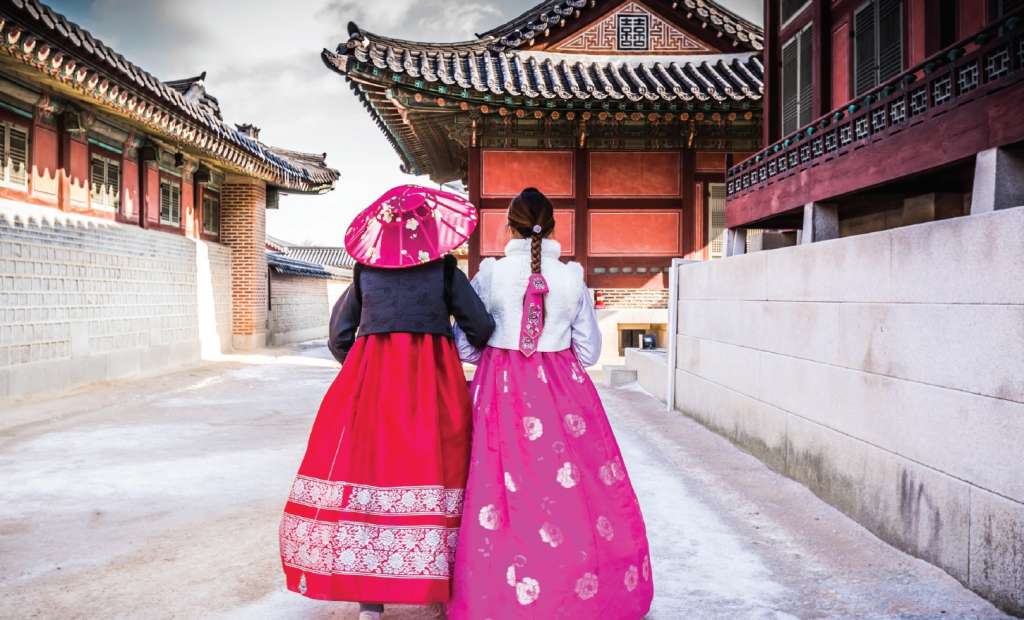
281, 513, 458, 579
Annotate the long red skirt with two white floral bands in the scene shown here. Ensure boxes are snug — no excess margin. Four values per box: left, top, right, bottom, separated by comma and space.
281, 333, 471, 605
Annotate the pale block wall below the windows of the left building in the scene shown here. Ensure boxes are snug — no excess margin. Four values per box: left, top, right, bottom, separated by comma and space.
0, 201, 231, 401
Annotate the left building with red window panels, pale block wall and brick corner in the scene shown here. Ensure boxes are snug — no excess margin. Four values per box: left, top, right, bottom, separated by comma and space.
0, 0, 338, 400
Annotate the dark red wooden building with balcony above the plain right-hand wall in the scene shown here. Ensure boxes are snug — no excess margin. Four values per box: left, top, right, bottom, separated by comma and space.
726, 0, 1024, 246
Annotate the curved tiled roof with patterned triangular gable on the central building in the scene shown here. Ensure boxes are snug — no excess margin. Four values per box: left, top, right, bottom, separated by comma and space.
322, 0, 764, 182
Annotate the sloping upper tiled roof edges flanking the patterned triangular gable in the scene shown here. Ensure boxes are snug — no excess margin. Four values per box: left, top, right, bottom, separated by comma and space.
478, 0, 764, 51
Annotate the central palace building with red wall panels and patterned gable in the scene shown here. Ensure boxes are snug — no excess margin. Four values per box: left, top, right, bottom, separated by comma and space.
323, 0, 764, 350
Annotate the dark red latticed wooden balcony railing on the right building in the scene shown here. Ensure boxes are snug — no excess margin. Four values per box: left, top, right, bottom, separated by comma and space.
726, 9, 1024, 198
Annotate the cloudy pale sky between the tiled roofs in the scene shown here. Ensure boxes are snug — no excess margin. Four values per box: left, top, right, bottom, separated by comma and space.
44, 0, 762, 245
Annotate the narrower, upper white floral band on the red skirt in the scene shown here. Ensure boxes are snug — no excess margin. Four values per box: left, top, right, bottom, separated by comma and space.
288, 476, 464, 516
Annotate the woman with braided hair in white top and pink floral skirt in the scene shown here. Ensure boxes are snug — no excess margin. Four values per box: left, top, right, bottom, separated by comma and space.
447, 188, 653, 620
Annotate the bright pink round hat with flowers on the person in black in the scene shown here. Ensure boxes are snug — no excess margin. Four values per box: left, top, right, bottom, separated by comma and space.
345, 185, 477, 270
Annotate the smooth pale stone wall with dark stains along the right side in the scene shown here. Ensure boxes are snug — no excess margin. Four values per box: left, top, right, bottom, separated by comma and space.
675, 208, 1024, 614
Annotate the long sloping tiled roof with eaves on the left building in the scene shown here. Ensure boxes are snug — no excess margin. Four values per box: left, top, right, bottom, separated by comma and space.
0, 0, 338, 192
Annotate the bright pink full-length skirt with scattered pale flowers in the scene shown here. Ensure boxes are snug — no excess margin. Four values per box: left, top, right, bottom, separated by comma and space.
449, 348, 653, 620
